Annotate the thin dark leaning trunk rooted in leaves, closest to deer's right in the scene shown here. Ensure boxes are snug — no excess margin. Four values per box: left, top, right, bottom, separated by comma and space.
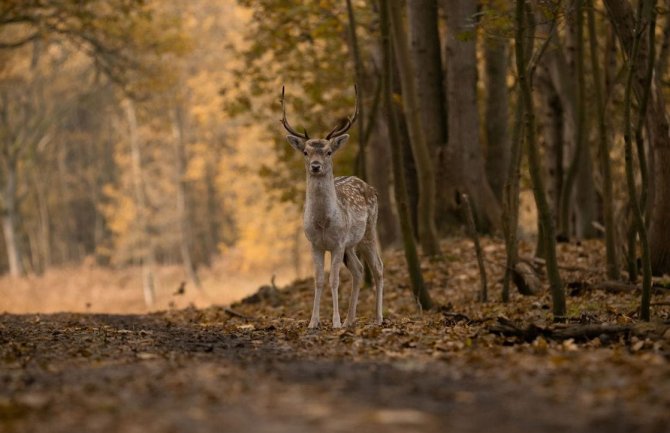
380, 0, 432, 309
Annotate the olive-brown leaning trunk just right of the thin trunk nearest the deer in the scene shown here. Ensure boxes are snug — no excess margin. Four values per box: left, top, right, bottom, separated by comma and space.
388, 1, 440, 256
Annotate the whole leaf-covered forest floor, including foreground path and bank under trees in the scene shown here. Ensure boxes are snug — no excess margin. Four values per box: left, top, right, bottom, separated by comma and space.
0, 238, 670, 433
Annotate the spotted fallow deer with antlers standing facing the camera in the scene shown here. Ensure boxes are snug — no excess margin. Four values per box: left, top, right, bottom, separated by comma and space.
280, 86, 384, 329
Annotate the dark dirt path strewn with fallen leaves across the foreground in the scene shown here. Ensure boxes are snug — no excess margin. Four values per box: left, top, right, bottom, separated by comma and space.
0, 310, 670, 433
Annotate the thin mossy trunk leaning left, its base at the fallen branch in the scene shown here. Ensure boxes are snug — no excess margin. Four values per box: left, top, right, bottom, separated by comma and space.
515, 0, 566, 318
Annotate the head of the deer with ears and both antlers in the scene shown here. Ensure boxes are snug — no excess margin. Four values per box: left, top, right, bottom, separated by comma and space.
280, 86, 358, 176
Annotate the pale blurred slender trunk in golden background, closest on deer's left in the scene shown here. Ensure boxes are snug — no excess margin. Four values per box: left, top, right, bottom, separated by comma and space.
172, 102, 201, 288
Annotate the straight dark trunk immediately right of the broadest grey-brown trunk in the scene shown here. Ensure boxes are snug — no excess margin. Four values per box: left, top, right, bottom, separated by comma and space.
484, 4, 510, 200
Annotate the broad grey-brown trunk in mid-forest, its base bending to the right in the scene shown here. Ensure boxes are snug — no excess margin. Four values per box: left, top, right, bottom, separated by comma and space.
445, 0, 501, 231
